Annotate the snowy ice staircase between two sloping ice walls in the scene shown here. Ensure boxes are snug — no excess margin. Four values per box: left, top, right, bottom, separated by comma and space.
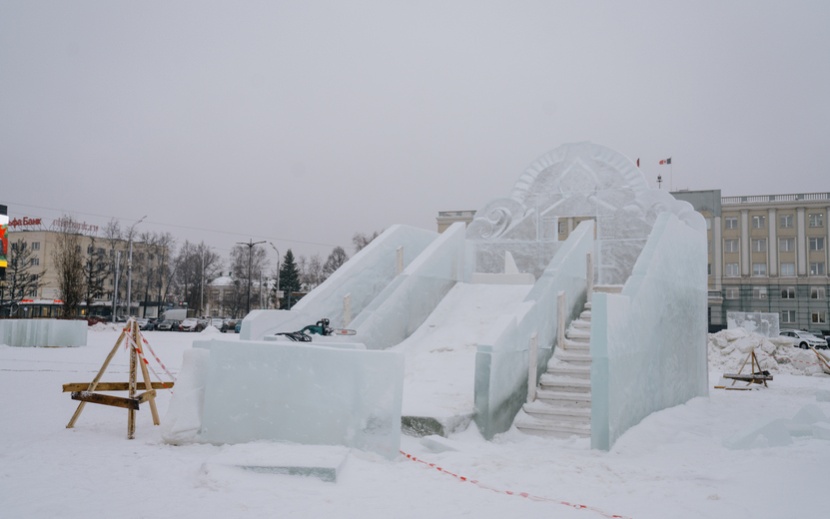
514, 285, 622, 438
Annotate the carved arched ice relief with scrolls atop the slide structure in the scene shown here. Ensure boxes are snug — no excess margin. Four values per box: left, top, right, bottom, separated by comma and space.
467, 142, 705, 284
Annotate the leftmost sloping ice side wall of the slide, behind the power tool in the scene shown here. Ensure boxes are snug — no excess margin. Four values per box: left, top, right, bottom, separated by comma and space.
240, 225, 439, 340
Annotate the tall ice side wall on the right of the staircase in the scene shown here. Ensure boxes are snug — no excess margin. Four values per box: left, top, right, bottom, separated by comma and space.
591, 212, 708, 450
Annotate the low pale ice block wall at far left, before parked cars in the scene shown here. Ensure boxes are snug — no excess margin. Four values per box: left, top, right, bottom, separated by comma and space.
0, 319, 88, 347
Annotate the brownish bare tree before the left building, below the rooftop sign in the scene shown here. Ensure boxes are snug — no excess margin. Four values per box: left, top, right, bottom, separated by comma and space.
52, 216, 86, 318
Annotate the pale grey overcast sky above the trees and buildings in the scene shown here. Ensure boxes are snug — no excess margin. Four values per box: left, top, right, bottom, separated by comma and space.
0, 0, 830, 266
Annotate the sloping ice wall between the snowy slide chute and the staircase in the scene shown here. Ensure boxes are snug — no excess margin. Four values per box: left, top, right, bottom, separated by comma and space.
475, 221, 595, 439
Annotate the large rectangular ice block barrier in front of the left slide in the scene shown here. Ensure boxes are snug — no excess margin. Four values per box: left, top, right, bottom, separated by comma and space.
194, 340, 404, 458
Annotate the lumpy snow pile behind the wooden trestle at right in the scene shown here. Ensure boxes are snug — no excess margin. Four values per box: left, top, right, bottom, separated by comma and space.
709, 328, 823, 375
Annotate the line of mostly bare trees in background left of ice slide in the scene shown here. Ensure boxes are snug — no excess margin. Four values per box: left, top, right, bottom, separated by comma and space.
0, 213, 380, 317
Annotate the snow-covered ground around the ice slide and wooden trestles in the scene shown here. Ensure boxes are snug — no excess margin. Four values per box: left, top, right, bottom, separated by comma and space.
0, 330, 830, 519
